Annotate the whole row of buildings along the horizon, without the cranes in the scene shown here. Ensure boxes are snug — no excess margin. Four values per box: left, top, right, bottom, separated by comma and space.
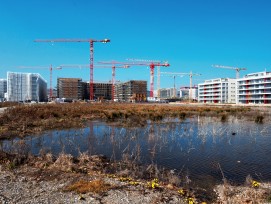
0, 71, 271, 104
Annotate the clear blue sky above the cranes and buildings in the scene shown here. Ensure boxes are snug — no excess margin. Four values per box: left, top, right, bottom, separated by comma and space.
0, 0, 271, 87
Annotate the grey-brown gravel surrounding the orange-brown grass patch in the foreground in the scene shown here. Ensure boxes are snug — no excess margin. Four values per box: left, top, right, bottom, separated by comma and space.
0, 165, 187, 204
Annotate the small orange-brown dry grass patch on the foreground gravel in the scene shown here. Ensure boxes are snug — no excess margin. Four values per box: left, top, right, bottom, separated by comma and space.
65, 180, 112, 194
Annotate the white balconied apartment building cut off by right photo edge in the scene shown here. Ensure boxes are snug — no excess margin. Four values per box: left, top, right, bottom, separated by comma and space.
236, 71, 271, 104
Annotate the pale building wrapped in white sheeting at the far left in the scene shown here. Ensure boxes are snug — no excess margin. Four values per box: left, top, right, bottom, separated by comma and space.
7, 72, 48, 102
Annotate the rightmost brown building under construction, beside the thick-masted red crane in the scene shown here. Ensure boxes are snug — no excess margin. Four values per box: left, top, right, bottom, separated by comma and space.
114, 80, 147, 102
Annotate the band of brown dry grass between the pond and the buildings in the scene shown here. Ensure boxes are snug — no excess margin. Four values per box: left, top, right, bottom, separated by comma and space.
0, 103, 255, 139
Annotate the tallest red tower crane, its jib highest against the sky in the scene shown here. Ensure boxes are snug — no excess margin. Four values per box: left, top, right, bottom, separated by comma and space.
34, 38, 110, 100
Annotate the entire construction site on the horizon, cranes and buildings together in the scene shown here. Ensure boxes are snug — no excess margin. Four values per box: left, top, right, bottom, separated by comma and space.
0, 39, 271, 104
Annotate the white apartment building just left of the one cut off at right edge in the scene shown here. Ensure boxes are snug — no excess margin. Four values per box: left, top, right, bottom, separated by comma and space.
198, 78, 236, 103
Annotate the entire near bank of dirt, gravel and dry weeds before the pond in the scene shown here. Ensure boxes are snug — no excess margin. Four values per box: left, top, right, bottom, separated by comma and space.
0, 152, 271, 204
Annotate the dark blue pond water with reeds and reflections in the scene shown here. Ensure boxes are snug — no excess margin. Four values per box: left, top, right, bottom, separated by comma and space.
0, 118, 271, 187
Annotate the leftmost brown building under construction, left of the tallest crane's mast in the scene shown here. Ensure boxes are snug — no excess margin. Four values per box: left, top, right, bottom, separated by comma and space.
57, 78, 84, 100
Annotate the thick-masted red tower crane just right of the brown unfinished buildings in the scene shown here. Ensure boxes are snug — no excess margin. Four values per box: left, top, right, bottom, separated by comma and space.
99, 59, 170, 97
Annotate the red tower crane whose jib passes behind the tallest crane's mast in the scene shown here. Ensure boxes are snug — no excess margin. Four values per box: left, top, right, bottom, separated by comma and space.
59, 64, 130, 101
